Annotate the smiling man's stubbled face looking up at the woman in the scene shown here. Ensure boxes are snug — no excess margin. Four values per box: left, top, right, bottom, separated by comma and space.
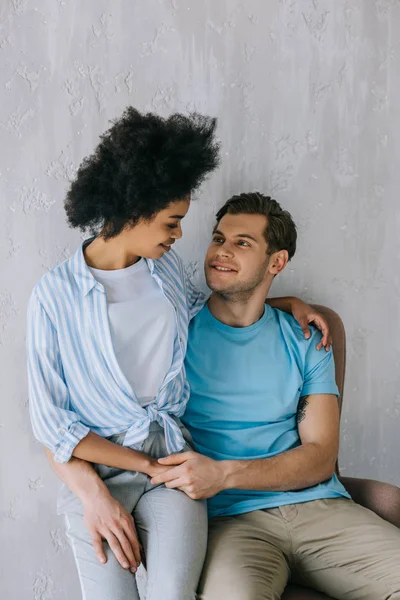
204, 214, 270, 297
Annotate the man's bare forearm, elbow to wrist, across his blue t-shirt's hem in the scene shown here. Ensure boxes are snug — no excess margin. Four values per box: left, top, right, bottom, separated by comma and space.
221, 443, 336, 492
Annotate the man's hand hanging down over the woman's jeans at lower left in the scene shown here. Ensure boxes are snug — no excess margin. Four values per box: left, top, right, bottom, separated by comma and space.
83, 491, 142, 573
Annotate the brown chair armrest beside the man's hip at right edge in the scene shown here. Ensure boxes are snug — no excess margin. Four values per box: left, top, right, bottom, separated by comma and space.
340, 477, 400, 528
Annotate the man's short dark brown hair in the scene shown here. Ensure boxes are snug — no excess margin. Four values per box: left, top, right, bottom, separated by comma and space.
216, 192, 297, 260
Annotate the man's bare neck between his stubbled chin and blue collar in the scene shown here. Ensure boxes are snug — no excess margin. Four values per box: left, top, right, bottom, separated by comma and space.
207, 289, 266, 327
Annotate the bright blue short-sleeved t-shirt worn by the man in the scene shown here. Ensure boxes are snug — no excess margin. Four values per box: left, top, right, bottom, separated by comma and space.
182, 305, 349, 517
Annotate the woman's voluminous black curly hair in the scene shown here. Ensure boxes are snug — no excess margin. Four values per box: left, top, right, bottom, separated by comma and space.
65, 107, 219, 239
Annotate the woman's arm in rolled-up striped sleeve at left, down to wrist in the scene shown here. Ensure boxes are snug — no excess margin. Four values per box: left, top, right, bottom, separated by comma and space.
27, 291, 157, 473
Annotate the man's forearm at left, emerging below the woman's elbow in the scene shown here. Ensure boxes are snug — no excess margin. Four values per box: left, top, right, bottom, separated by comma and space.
45, 448, 109, 503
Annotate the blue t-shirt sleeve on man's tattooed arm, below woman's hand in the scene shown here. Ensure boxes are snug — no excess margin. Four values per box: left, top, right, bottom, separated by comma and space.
300, 327, 339, 396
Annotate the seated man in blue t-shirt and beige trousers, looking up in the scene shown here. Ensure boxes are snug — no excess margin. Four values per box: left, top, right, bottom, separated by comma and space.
152, 193, 400, 600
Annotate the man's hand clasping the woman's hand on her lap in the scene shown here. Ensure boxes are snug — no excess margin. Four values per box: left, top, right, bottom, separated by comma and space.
151, 452, 225, 500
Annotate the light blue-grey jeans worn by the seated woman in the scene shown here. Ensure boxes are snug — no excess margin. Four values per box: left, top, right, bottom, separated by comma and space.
58, 420, 207, 600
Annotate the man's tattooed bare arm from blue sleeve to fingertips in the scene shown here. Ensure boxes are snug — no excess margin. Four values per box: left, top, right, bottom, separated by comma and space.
152, 394, 339, 499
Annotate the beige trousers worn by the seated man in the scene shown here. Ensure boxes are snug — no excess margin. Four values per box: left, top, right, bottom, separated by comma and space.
199, 498, 400, 600
